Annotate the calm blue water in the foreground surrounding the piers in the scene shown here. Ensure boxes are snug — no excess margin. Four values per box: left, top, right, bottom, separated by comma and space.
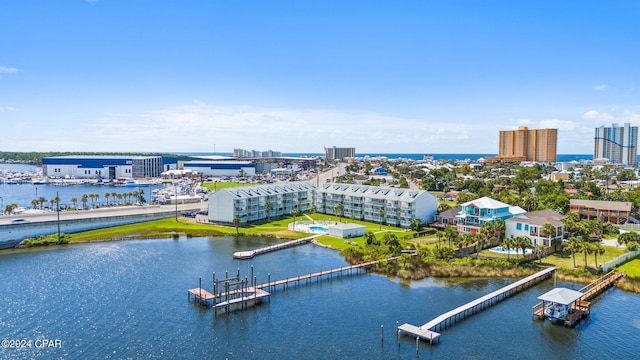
0, 237, 640, 359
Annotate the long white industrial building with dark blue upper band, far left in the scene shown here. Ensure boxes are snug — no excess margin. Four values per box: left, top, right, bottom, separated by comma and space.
42, 155, 163, 180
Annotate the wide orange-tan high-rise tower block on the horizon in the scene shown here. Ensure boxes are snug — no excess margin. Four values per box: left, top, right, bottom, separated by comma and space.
485, 126, 558, 163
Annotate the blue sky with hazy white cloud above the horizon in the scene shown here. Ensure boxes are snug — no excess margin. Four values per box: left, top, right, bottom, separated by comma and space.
0, 0, 640, 154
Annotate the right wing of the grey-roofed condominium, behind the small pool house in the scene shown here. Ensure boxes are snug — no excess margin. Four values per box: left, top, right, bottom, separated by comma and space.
316, 183, 438, 227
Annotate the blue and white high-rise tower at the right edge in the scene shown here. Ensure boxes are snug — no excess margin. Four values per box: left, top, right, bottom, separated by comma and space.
593, 123, 638, 166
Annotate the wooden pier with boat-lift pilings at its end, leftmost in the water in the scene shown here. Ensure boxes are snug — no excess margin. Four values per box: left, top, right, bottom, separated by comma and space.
187, 256, 400, 311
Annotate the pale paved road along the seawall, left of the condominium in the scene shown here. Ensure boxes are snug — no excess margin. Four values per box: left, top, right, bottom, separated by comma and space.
0, 202, 208, 225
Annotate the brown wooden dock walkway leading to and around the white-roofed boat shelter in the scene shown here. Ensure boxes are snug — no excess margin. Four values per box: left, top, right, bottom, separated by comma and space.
531, 270, 624, 327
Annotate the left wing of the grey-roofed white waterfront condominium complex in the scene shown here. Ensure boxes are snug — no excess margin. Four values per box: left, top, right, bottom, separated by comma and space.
208, 181, 315, 223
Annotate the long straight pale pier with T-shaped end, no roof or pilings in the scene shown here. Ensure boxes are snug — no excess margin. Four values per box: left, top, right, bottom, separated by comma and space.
396, 267, 556, 343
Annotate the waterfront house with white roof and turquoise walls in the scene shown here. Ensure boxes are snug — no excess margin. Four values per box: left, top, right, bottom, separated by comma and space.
457, 196, 526, 234
